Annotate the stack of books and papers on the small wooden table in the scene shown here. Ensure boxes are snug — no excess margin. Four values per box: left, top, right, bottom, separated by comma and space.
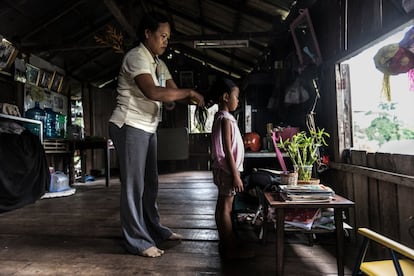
280, 184, 335, 202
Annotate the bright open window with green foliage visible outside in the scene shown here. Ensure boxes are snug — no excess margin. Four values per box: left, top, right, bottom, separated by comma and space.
337, 25, 414, 154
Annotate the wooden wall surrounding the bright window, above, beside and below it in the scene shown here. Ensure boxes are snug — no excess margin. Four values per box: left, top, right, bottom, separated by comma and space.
310, 0, 414, 252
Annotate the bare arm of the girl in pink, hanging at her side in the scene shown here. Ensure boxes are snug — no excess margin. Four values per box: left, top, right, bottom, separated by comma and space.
221, 119, 244, 192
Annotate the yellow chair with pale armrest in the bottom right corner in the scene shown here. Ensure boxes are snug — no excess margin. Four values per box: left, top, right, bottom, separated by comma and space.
352, 228, 414, 276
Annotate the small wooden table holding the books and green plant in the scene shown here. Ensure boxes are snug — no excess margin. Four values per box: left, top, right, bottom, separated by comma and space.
265, 192, 354, 275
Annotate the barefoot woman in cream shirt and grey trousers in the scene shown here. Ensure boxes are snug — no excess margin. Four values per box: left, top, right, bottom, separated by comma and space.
109, 11, 204, 257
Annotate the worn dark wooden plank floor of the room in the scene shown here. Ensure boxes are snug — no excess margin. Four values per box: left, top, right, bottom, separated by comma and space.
0, 172, 356, 276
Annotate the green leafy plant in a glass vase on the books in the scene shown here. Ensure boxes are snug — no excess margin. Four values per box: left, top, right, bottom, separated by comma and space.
278, 128, 330, 181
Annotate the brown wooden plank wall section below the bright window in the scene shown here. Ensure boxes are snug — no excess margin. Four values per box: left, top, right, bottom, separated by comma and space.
323, 153, 414, 250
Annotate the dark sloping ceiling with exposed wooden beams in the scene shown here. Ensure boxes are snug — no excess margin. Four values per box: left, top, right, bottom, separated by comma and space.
0, 0, 315, 92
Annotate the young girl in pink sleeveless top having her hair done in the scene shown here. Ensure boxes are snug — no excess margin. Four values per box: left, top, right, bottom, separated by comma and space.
209, 79, 253, 259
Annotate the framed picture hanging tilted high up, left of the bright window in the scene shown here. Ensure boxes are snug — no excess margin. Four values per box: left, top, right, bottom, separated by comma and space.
290, 9, 322, 66
